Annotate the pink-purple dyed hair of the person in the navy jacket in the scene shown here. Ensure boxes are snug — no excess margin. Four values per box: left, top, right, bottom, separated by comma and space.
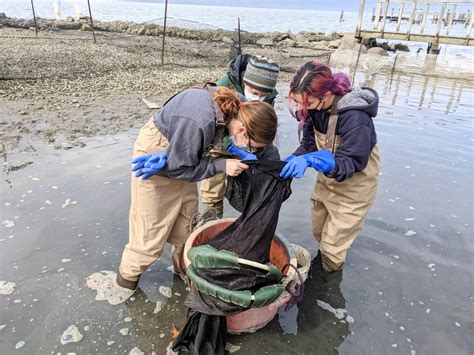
288, 60, 352, 124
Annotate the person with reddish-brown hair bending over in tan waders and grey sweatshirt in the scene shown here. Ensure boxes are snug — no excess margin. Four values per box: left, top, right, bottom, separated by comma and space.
117, 85, 277, 290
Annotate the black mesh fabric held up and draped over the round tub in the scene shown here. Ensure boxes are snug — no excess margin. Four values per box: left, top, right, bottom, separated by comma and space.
173, 160, 291, 355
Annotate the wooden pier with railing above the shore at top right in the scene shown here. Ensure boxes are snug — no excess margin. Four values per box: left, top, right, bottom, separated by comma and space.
356, 0, 474, 48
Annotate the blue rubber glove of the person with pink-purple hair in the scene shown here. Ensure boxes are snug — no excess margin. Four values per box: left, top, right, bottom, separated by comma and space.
280, 150, 336, 180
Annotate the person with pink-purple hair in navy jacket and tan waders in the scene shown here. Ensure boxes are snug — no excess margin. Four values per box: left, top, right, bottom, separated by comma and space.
280, 61, 380, 272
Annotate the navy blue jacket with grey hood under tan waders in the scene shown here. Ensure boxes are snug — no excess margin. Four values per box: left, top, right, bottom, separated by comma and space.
293, 88, 379, 181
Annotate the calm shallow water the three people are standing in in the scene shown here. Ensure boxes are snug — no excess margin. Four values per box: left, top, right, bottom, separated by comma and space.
0, 74, 474, 355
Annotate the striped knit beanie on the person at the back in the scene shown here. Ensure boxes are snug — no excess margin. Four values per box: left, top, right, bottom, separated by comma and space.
242, 56, 280, 92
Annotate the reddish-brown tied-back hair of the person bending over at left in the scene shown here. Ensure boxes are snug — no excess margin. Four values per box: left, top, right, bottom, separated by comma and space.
213, 87, 278, 145
